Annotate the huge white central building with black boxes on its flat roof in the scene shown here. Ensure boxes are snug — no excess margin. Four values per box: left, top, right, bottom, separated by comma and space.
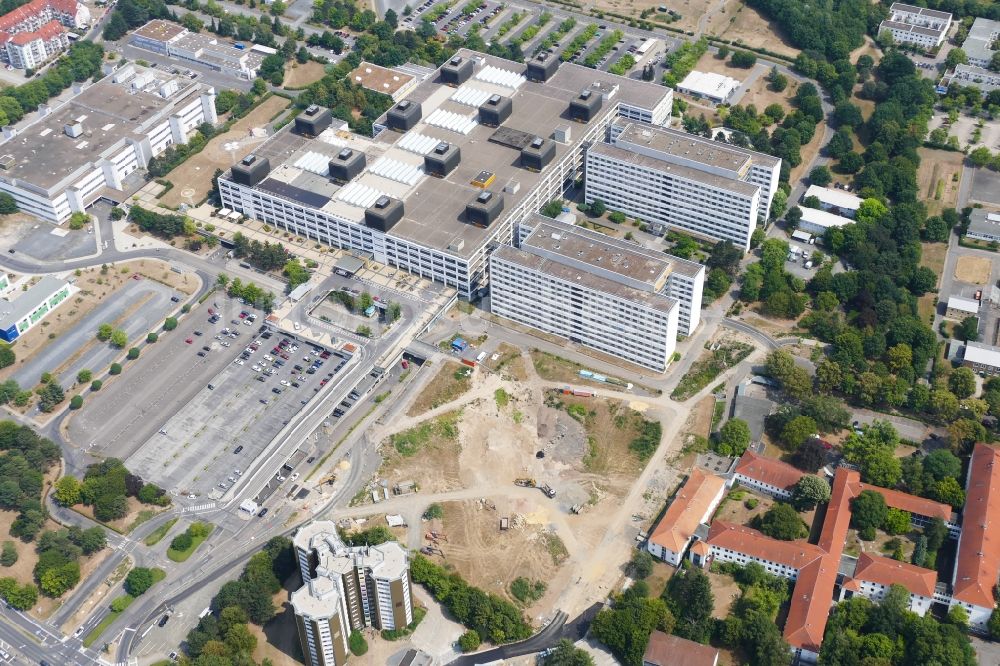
219, 50, 673, 298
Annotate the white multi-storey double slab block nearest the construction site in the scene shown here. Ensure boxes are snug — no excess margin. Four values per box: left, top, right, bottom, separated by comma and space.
490, 222, 705, 371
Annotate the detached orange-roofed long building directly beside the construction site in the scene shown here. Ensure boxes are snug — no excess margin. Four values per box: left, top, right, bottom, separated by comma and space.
646, 467, 726, 567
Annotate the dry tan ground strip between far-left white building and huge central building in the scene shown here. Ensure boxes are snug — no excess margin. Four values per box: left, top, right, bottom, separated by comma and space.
160, 95, 291, 208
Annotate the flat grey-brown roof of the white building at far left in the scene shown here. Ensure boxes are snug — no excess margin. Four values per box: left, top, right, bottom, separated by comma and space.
0, 65, 208, 191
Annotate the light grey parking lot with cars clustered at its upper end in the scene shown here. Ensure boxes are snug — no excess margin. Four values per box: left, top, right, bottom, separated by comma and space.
127, 306, 350, 499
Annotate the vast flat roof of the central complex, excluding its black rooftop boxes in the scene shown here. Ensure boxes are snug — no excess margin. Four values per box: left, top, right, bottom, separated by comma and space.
223, 49, 670, 257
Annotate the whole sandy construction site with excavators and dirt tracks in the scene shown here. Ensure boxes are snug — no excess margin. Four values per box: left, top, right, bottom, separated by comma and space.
341, 348, 676, 617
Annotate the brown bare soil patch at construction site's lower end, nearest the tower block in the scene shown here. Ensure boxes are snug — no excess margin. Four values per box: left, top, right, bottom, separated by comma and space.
435, 500, 565, 606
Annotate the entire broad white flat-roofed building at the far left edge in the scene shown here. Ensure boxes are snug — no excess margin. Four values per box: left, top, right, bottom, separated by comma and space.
0, 64, 218, 224
